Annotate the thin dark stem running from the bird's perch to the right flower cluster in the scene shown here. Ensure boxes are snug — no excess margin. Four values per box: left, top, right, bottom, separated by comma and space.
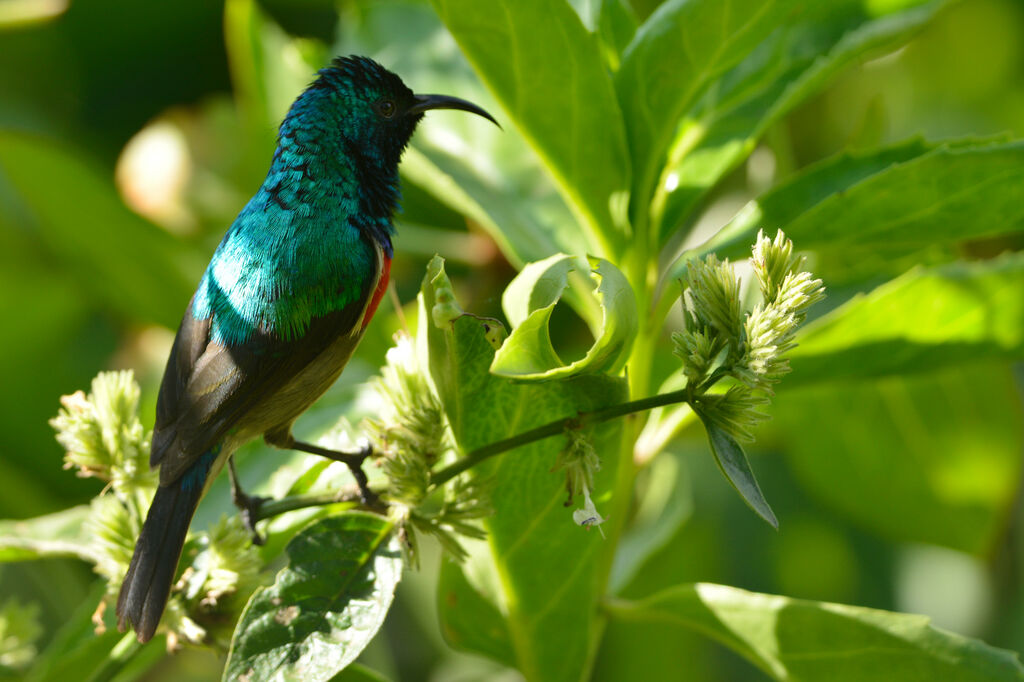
430, 388, 689, 485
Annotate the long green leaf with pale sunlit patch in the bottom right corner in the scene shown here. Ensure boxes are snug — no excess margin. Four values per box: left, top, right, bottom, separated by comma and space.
607, 583, 1024, 682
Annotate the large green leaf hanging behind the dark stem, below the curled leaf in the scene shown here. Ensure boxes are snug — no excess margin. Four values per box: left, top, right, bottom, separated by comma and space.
417, 259, 632, 680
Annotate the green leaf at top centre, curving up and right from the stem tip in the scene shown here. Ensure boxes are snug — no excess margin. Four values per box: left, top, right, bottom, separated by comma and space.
615, 0, 796, 216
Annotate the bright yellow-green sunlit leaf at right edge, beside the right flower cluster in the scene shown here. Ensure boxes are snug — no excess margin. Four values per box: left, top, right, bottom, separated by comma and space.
786, 253, 1024, 387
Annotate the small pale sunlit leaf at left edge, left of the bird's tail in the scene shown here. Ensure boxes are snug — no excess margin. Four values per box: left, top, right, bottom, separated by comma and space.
0, 505, 96, 562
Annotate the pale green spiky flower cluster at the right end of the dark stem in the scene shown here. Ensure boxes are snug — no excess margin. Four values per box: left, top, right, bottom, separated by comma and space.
673, 231, 824, 440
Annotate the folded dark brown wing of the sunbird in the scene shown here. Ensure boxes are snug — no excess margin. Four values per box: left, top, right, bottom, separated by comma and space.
150, 246, 381, 485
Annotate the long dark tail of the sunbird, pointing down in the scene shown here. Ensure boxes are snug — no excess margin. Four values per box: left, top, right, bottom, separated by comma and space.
117, 453, 215, 642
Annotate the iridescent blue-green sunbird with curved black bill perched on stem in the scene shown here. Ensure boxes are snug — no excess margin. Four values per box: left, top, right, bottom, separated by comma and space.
117, 55, 498, 642
